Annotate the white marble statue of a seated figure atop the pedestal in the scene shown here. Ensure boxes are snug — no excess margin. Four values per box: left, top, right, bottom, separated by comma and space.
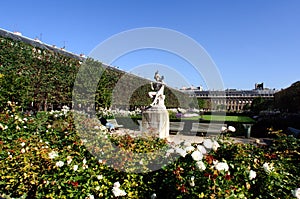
148, 71, 165, 108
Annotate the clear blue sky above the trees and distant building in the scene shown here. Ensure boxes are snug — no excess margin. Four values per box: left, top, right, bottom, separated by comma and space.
0, 0, 300, 89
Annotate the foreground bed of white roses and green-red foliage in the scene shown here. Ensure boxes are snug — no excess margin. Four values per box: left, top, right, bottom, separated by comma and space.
0, 103, 300, 198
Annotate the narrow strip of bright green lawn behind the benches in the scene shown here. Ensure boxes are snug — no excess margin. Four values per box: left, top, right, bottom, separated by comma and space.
184, 115, 254, 123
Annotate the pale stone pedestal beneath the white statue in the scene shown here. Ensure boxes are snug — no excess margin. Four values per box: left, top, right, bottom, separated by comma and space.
141, 106, 170, 139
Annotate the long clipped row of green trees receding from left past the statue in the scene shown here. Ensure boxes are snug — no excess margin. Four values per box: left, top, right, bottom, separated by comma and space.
0, 37, 191, 111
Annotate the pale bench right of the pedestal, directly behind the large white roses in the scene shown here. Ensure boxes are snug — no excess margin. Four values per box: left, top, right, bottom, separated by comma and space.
190, 123, 227, 136
